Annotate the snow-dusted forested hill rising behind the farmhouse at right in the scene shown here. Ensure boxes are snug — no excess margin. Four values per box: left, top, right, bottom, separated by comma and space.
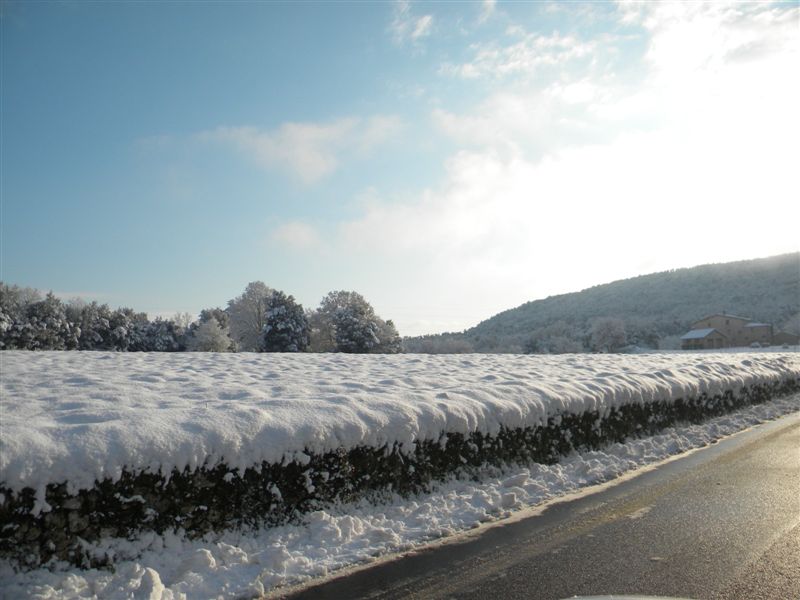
405, 253, 800, 352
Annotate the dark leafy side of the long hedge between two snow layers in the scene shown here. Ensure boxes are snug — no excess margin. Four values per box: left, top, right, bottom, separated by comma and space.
0, 378, 800, 568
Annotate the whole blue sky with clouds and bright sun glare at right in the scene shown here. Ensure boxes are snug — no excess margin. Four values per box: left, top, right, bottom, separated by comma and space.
0, 1, 800, 335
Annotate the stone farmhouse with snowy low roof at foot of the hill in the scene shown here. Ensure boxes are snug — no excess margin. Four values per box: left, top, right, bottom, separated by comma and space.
681, 313, 797, 350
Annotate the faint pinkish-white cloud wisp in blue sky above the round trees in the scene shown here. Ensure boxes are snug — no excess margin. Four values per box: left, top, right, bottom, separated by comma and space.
198, 116, 401, 183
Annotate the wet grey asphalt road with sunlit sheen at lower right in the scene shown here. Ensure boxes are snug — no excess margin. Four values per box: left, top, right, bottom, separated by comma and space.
282, 413, 800, 600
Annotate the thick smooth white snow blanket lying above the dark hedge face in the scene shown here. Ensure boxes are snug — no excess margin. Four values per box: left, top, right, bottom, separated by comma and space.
0, 352, 800, 493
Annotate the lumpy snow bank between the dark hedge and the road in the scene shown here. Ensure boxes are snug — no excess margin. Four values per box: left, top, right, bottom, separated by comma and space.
0, 394, 800, 600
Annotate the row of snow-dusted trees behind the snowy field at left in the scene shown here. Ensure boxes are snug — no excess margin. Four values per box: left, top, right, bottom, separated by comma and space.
0, 281, 402, 354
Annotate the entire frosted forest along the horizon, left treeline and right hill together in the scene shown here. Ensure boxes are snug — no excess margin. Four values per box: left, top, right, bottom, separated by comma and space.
6, 252, 800, 354
